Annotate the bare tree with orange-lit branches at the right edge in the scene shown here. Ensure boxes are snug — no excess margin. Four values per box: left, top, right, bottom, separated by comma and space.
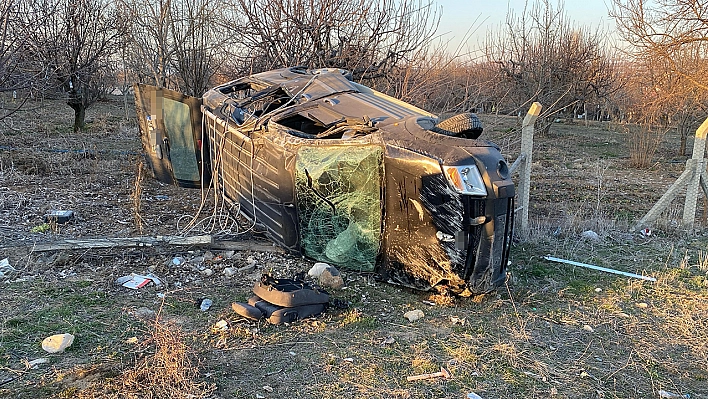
612, 0, 708, 155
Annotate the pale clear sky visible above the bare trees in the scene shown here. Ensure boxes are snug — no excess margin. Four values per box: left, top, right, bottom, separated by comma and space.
434, 0, 615, 54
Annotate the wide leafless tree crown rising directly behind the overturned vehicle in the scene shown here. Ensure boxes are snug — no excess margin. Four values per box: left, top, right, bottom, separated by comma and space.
226, 0, 439, 81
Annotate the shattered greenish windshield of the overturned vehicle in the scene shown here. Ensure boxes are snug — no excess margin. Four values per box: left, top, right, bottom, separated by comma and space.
295, 145, 383, 271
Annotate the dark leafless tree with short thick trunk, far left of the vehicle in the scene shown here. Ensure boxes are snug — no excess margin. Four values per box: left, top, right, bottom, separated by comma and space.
19, 0, 122, 131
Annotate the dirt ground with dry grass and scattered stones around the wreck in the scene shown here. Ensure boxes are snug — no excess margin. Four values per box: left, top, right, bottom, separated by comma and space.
0, 95, 708, 399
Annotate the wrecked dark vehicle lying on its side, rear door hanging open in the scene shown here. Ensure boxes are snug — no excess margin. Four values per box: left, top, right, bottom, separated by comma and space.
136, 67, 514, 295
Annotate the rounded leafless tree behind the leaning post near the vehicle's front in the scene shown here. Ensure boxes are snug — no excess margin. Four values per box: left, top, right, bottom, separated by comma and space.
485, 0, 617, 126
